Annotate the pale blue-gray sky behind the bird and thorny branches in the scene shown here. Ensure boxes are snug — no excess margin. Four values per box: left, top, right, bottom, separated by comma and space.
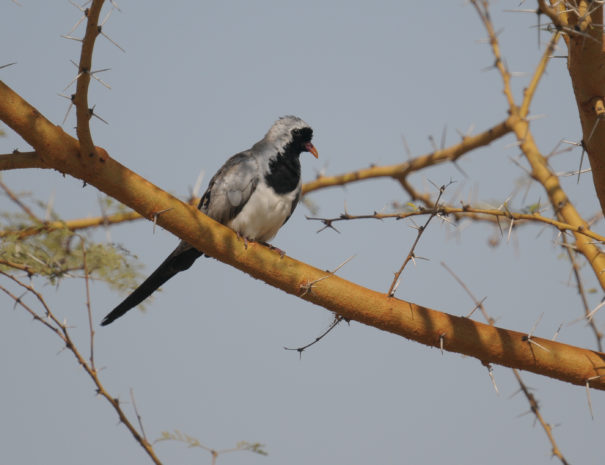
0, 0, 605, 465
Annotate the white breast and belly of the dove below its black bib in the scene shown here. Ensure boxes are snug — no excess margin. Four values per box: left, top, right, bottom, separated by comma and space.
227, 182, 300, 242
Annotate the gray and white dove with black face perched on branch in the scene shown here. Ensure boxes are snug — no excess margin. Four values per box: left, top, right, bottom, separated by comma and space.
101, 115, 319, 326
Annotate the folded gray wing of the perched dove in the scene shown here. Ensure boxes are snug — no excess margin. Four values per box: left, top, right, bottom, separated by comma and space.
198, 151, 260, 224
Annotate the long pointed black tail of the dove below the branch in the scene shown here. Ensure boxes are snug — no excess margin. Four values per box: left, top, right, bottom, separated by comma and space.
101, 242, 203, 326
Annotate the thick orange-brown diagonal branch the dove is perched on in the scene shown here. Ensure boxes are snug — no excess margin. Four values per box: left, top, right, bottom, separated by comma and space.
0, 81, 605, 390
